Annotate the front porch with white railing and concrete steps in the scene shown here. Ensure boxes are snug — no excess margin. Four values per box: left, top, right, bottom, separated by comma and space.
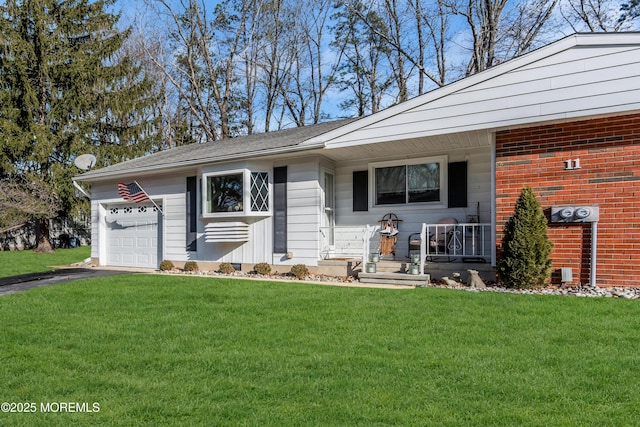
318, 221, 495, 285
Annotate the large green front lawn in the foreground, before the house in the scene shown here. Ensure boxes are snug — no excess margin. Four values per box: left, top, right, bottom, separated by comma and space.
0, 275, 640, 426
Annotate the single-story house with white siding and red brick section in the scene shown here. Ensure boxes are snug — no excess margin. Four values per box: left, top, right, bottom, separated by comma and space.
75, 33, 640, 286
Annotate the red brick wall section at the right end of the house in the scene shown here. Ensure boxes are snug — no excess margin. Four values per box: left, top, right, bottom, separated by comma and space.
496, 114, 640, 286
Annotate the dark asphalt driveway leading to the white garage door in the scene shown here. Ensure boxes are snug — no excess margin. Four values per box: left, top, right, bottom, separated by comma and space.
0, 268, 133, 296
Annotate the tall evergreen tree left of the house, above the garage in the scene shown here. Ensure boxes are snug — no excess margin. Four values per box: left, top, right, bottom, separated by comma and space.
0, 0, 159, 251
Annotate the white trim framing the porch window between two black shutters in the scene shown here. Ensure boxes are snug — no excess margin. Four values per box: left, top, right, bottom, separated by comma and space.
369, 155, 449, 210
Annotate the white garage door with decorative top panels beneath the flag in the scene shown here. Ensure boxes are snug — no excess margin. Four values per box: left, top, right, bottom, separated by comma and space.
106, 203, 161, 268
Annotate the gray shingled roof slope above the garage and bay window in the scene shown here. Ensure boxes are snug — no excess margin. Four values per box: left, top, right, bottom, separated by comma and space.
76, 119, 356, 181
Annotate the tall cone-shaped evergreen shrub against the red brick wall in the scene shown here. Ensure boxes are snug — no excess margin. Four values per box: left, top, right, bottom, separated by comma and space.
497, 187, 553, 289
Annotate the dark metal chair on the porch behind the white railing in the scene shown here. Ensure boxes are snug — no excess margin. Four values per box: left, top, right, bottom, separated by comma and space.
407, 217, 462, 262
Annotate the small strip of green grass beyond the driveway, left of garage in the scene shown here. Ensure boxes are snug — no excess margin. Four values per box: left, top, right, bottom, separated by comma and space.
0, 246, 91, 277
